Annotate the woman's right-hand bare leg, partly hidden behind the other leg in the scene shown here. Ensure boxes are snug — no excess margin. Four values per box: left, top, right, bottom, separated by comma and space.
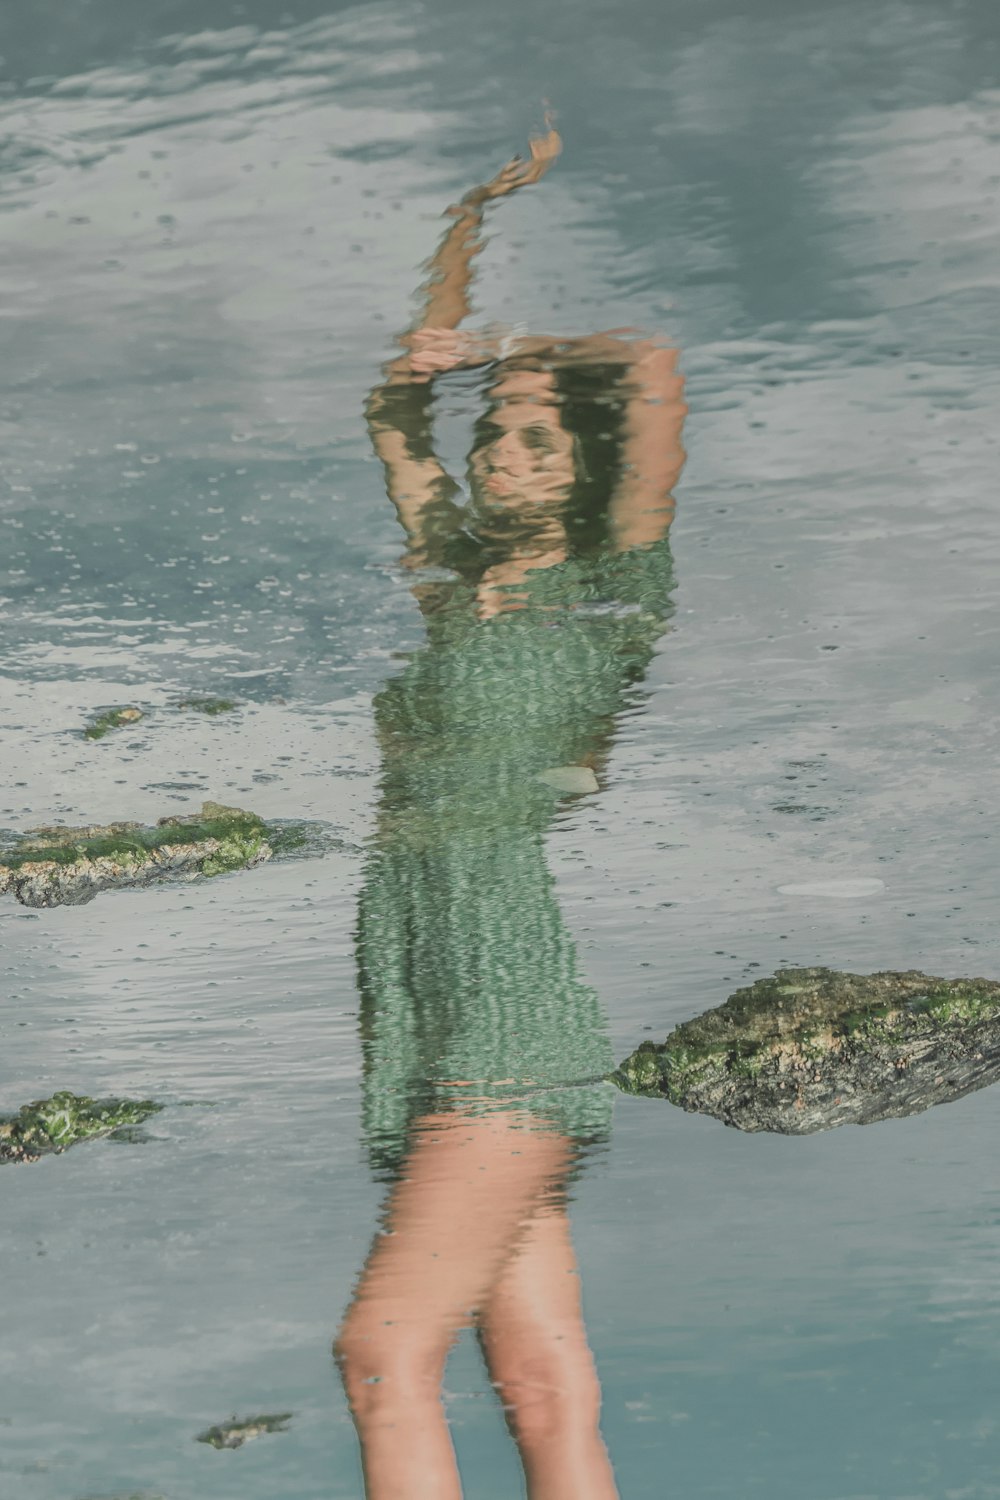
481, 1206, 618, 1500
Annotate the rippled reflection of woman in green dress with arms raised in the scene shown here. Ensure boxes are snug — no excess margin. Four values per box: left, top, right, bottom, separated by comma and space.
336, 132, 685, 1500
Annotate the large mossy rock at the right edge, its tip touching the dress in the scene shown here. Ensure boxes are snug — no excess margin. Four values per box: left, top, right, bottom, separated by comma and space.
612, 969, 1000, 1136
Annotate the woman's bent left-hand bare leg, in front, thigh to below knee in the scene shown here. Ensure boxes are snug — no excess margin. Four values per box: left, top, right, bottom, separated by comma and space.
336, 1113, 568, 1500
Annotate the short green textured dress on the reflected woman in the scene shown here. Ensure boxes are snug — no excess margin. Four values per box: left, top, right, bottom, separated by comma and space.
357, 539, 672, 1173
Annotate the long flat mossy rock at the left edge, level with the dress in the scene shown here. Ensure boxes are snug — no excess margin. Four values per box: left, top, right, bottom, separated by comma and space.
0, 803, 281, 906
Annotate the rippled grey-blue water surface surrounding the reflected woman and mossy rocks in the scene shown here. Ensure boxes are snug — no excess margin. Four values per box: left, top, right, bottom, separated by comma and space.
0, 0, 1000, 1500
